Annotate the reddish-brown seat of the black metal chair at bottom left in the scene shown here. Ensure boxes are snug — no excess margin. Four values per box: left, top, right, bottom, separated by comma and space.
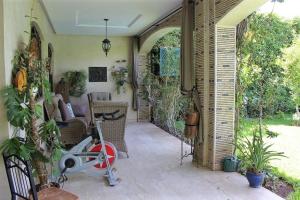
38, 187, 79, 200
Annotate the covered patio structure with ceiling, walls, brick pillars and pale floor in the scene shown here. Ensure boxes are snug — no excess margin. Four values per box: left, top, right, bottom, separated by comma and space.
0, 0, 281, 200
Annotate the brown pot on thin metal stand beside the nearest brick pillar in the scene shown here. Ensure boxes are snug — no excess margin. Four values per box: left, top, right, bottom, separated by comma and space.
184, 112, 199, 139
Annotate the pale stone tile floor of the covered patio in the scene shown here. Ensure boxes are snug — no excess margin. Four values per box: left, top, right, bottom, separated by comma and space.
64, 123, 282, 200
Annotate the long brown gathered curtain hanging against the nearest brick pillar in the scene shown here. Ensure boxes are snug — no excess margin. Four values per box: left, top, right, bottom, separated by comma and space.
181, 0, 195, 94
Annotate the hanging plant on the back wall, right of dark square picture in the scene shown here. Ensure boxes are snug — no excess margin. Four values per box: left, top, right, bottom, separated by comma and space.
111, 67, 128, 94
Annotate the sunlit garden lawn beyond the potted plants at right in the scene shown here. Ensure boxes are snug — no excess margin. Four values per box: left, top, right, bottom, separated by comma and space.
240, 114, 300, 200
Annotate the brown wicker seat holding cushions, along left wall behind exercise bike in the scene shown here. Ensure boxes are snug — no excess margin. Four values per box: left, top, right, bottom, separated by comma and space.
44, 95, 88, 145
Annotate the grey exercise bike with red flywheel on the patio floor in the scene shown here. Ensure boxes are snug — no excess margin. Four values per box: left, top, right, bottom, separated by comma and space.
59, 111, 124, 186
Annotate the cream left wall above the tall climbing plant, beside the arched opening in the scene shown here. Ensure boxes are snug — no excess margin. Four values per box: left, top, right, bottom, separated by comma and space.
4, 0, 55, 84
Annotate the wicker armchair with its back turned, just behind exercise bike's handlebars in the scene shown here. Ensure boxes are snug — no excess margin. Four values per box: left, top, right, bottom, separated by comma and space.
89, 97, 128, 157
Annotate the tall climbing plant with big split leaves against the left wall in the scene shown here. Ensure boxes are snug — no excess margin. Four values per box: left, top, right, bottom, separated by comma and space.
0, 6, 61, 186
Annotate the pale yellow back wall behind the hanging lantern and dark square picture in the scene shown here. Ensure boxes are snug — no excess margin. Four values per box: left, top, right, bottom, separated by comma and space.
54, 35, 137, 121
